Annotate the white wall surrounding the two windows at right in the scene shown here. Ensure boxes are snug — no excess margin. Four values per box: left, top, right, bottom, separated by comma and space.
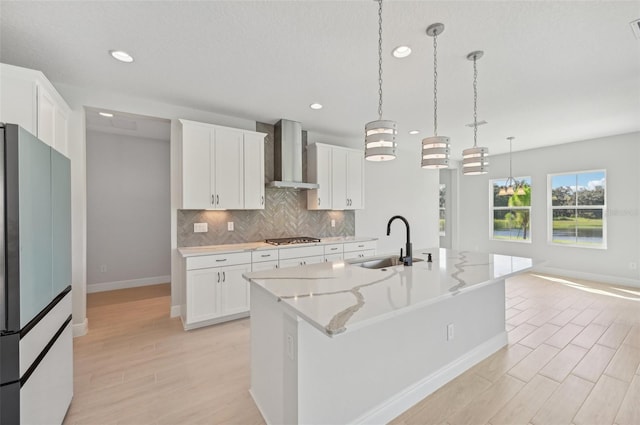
458, 133, 640, 286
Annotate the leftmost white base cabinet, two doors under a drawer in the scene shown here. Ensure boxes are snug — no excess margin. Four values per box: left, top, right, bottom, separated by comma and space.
182, 252, 251, 329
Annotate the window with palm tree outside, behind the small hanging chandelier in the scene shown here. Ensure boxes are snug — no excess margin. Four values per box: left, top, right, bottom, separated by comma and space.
489, 177, 531, 242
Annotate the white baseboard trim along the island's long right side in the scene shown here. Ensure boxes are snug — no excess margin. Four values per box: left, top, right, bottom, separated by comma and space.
353, 332, 507, 424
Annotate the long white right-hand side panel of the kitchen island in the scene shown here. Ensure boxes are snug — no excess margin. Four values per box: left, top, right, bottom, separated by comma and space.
296, 280, 507, 424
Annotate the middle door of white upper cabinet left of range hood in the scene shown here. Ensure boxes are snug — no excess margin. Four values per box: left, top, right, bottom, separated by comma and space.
211, 128, 244, 210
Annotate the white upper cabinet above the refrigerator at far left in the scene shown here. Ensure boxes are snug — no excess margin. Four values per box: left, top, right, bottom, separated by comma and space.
0, 64, 71, 155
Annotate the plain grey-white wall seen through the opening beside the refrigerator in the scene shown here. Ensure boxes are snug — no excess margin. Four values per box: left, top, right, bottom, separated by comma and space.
86, 131, 171, 292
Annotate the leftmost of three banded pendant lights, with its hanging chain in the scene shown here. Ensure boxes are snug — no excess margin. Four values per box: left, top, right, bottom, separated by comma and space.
364, 0, 398, 161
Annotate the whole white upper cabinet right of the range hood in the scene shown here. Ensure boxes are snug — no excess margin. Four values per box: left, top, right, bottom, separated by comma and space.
307, 143, 364, 210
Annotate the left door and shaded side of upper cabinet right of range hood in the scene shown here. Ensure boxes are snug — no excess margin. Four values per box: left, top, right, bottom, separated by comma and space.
307, 143, 333, 210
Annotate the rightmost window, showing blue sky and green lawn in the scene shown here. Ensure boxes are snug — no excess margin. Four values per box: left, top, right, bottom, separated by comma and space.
549, 170, 607, 248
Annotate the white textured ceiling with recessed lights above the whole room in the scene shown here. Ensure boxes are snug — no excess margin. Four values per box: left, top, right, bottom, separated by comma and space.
0, 0, 640, 158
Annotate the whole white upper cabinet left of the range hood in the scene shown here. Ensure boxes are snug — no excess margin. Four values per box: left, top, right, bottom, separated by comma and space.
180, 120, 265, 210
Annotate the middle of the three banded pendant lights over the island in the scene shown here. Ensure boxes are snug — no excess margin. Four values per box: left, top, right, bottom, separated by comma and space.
422, 23, 449, 169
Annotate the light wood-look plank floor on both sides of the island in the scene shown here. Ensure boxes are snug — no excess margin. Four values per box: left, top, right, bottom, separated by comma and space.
65, 274, 640, 425
